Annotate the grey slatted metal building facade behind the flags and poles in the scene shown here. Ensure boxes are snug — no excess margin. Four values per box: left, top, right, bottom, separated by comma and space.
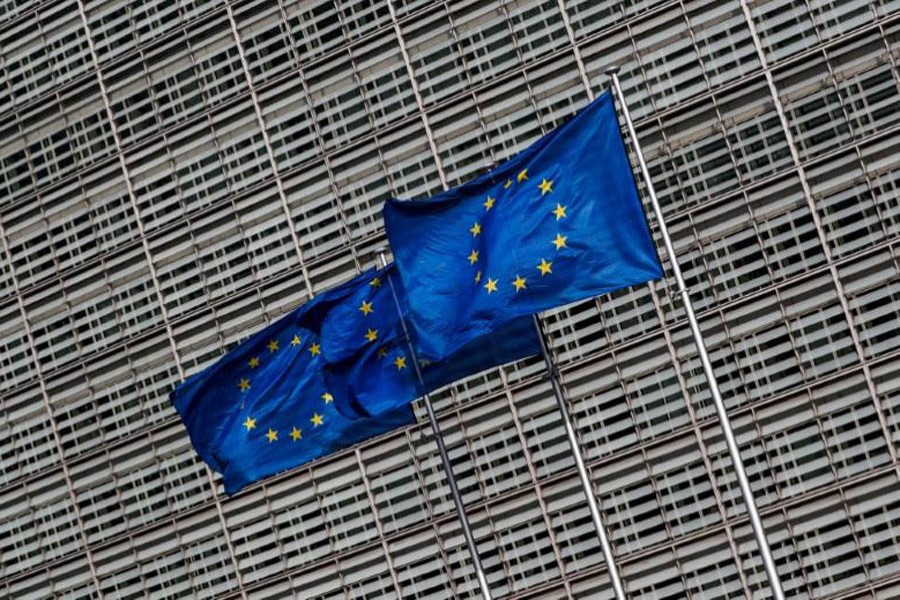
0, 0, 900, 600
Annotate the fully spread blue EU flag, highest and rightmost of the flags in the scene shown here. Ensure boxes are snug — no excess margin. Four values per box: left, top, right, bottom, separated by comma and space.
384, 92, 662, 360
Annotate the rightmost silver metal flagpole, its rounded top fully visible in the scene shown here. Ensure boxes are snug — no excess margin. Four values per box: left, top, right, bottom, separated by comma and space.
606, 67, 784, 600
